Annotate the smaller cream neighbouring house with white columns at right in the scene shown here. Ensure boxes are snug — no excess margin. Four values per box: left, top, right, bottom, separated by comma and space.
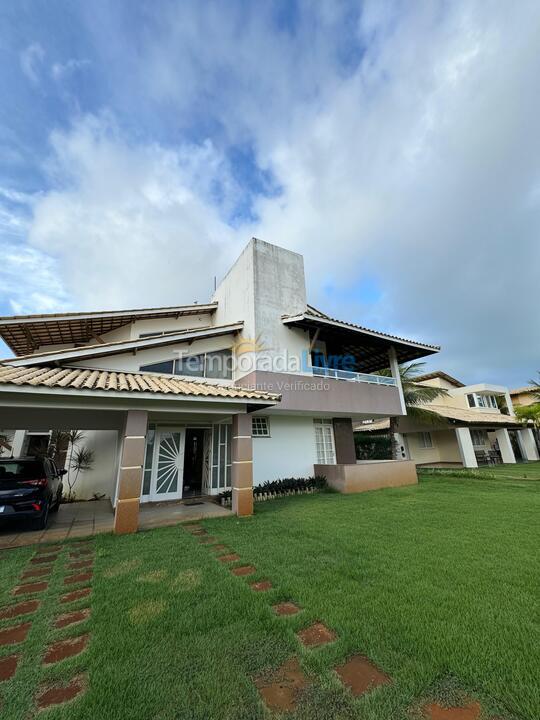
355, 371, 539, 468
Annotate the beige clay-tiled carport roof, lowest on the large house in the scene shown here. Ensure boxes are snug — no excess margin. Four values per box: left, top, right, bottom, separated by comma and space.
0, 365, 281, 404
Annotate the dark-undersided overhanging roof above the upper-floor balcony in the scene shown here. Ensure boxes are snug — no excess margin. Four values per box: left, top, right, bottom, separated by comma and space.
282, 305, 440, 372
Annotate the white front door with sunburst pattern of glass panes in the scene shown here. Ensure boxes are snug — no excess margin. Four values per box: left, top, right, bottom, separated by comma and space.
149, 428, 185, 502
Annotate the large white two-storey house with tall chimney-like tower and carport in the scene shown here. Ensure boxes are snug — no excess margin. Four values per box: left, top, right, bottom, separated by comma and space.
0, 239, 439, 532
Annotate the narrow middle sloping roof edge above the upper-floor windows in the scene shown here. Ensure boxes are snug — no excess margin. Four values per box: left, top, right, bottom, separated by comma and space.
0, 322, 244, 367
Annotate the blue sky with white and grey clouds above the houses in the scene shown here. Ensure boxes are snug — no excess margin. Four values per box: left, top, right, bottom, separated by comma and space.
0, 0, 540, 385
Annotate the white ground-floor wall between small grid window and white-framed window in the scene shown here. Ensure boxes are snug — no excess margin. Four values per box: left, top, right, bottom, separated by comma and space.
253, 413, 317, 485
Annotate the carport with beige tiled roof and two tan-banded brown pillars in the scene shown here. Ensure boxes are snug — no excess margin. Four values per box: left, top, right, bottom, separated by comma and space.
0, 366, 279, 533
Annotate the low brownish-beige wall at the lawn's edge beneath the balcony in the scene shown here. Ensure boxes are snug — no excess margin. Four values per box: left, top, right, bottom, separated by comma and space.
315, 460, 418, 494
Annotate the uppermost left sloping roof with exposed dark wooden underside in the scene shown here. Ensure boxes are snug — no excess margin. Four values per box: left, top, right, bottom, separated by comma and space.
0, 303, 217, 355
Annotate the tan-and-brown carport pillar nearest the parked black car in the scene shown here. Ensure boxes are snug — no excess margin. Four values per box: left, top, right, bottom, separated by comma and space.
114, 410, 148, 535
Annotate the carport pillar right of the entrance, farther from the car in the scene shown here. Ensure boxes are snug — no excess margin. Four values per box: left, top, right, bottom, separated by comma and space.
231, 413, 253, 517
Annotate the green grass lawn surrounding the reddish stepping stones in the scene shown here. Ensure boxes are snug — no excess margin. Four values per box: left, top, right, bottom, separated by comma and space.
0, 476, 540, 720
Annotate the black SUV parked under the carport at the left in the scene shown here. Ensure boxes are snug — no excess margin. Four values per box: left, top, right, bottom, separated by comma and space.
0, 457, 66, 530
